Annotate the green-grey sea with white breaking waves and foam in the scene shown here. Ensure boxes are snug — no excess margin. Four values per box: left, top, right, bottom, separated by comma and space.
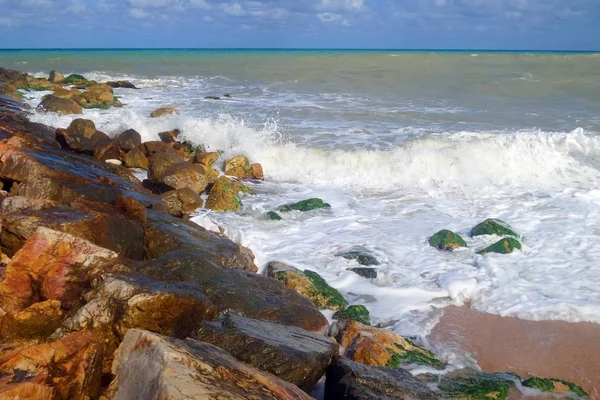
0, 49, 600, 356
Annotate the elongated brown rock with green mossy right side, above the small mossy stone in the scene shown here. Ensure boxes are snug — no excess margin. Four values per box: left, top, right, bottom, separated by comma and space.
266, 261, 348, 311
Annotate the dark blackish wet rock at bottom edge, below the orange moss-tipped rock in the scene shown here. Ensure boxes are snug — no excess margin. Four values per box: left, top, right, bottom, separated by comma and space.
324, 357, 439, 400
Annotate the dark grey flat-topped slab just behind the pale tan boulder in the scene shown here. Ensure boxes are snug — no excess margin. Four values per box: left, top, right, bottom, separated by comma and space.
191, 314, 338, 393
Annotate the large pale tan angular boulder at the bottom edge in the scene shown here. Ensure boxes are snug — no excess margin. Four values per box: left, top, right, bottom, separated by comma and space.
113, 329, 311, 400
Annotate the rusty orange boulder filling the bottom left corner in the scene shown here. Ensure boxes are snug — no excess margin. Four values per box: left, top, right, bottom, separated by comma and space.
0, 331, 102, 400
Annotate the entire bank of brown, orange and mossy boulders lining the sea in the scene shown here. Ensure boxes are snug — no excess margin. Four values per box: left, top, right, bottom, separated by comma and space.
0, 69, 587, 400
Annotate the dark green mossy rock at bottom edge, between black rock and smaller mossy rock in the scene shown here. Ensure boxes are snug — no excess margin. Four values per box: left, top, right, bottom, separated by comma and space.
438, 373, 516, 400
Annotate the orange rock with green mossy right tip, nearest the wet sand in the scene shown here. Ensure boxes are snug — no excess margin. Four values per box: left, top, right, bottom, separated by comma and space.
338, 321, 444, 368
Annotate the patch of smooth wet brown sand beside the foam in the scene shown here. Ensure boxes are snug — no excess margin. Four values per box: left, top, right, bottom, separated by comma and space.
429, 306, 600, 399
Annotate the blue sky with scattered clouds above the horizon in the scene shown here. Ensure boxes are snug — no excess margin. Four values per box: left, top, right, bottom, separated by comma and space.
0, 0, 600, 50
